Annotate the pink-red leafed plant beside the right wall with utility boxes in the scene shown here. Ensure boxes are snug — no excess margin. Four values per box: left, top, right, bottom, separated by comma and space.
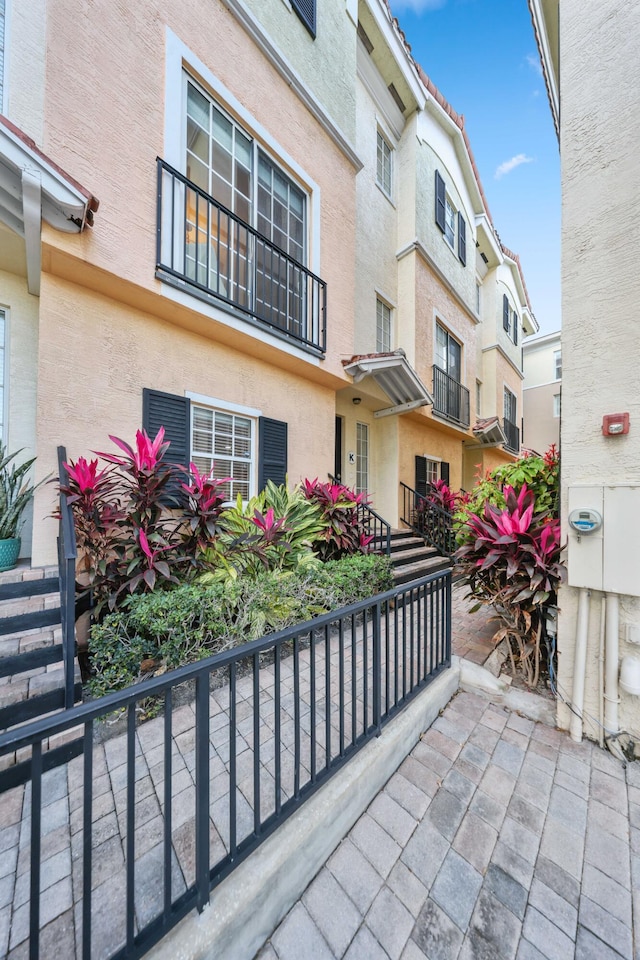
456, 484, 564, 687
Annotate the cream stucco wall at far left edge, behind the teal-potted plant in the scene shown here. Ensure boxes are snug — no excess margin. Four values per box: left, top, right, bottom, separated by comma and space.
0, 270, 39, 557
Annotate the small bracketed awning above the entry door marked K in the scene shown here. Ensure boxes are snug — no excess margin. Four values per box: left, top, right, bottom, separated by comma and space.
342, 350, 433, 417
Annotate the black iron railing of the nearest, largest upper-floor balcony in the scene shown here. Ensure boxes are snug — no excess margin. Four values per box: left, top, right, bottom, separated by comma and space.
156, 158, 327, 354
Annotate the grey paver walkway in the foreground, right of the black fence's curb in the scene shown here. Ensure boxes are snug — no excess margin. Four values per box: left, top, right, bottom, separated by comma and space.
258, 693, 640, 960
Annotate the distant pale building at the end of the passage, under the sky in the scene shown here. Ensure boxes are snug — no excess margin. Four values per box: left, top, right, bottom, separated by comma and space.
522, 330, 562, 453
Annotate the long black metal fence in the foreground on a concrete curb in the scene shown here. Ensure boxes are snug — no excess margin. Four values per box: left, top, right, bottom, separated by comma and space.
0, 571, 451, 960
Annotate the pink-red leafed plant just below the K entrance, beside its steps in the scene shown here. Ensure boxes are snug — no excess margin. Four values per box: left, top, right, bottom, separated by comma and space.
301, 478, 373, 561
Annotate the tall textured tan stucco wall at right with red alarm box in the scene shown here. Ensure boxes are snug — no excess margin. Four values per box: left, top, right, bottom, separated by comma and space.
558, 0, 640, 737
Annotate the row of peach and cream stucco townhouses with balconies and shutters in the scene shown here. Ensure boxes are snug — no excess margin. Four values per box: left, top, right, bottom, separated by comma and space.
0, 0, 536, 564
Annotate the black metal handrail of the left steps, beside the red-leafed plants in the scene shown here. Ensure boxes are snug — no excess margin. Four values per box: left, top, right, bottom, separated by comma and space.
58, 447, 78, 710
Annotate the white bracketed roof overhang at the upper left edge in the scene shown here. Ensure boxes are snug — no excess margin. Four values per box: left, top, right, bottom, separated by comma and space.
0, 116, 98, 296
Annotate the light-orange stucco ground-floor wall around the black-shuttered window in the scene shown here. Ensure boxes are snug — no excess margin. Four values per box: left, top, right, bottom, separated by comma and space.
33, 275, 335, 564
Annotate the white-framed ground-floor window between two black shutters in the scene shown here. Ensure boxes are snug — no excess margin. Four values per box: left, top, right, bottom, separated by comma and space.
191, 403, 257, 501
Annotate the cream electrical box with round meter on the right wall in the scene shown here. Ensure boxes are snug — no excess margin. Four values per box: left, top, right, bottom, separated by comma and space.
567, 485, 640, 597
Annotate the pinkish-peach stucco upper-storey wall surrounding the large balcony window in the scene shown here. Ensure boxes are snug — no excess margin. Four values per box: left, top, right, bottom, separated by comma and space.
42, 0, 355, 375
